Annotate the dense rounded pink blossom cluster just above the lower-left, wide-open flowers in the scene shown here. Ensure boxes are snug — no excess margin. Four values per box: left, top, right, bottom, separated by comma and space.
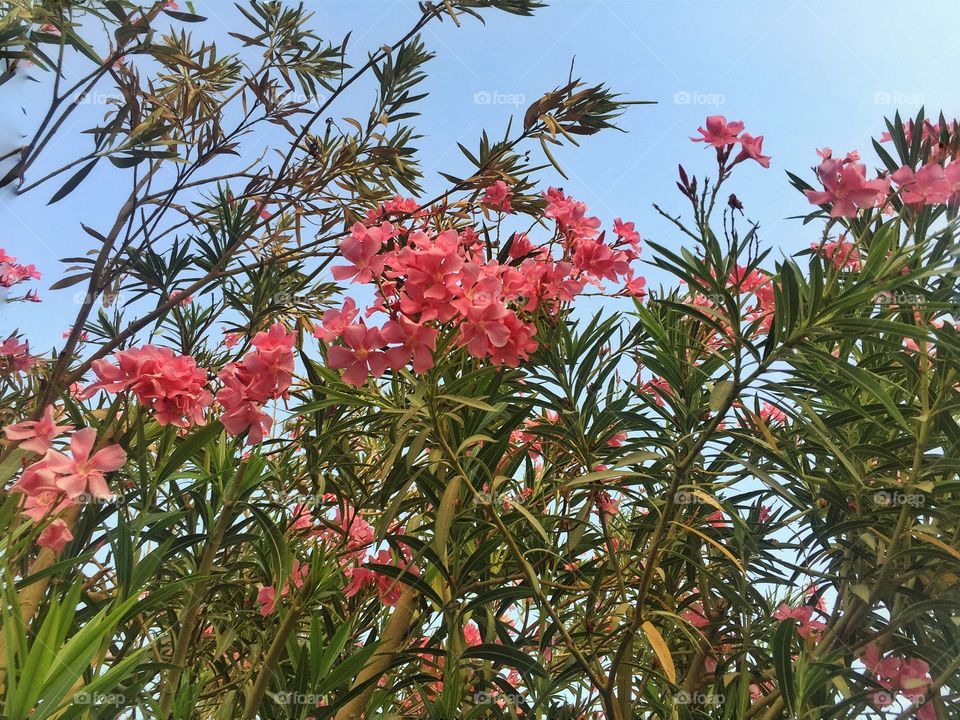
84, 345, 213, 427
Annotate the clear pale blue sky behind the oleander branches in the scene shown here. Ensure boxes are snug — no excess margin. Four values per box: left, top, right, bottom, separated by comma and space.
0, 0, 960, 352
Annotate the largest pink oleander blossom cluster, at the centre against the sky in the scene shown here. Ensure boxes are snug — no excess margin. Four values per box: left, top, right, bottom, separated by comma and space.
314, 188, 644, 386
